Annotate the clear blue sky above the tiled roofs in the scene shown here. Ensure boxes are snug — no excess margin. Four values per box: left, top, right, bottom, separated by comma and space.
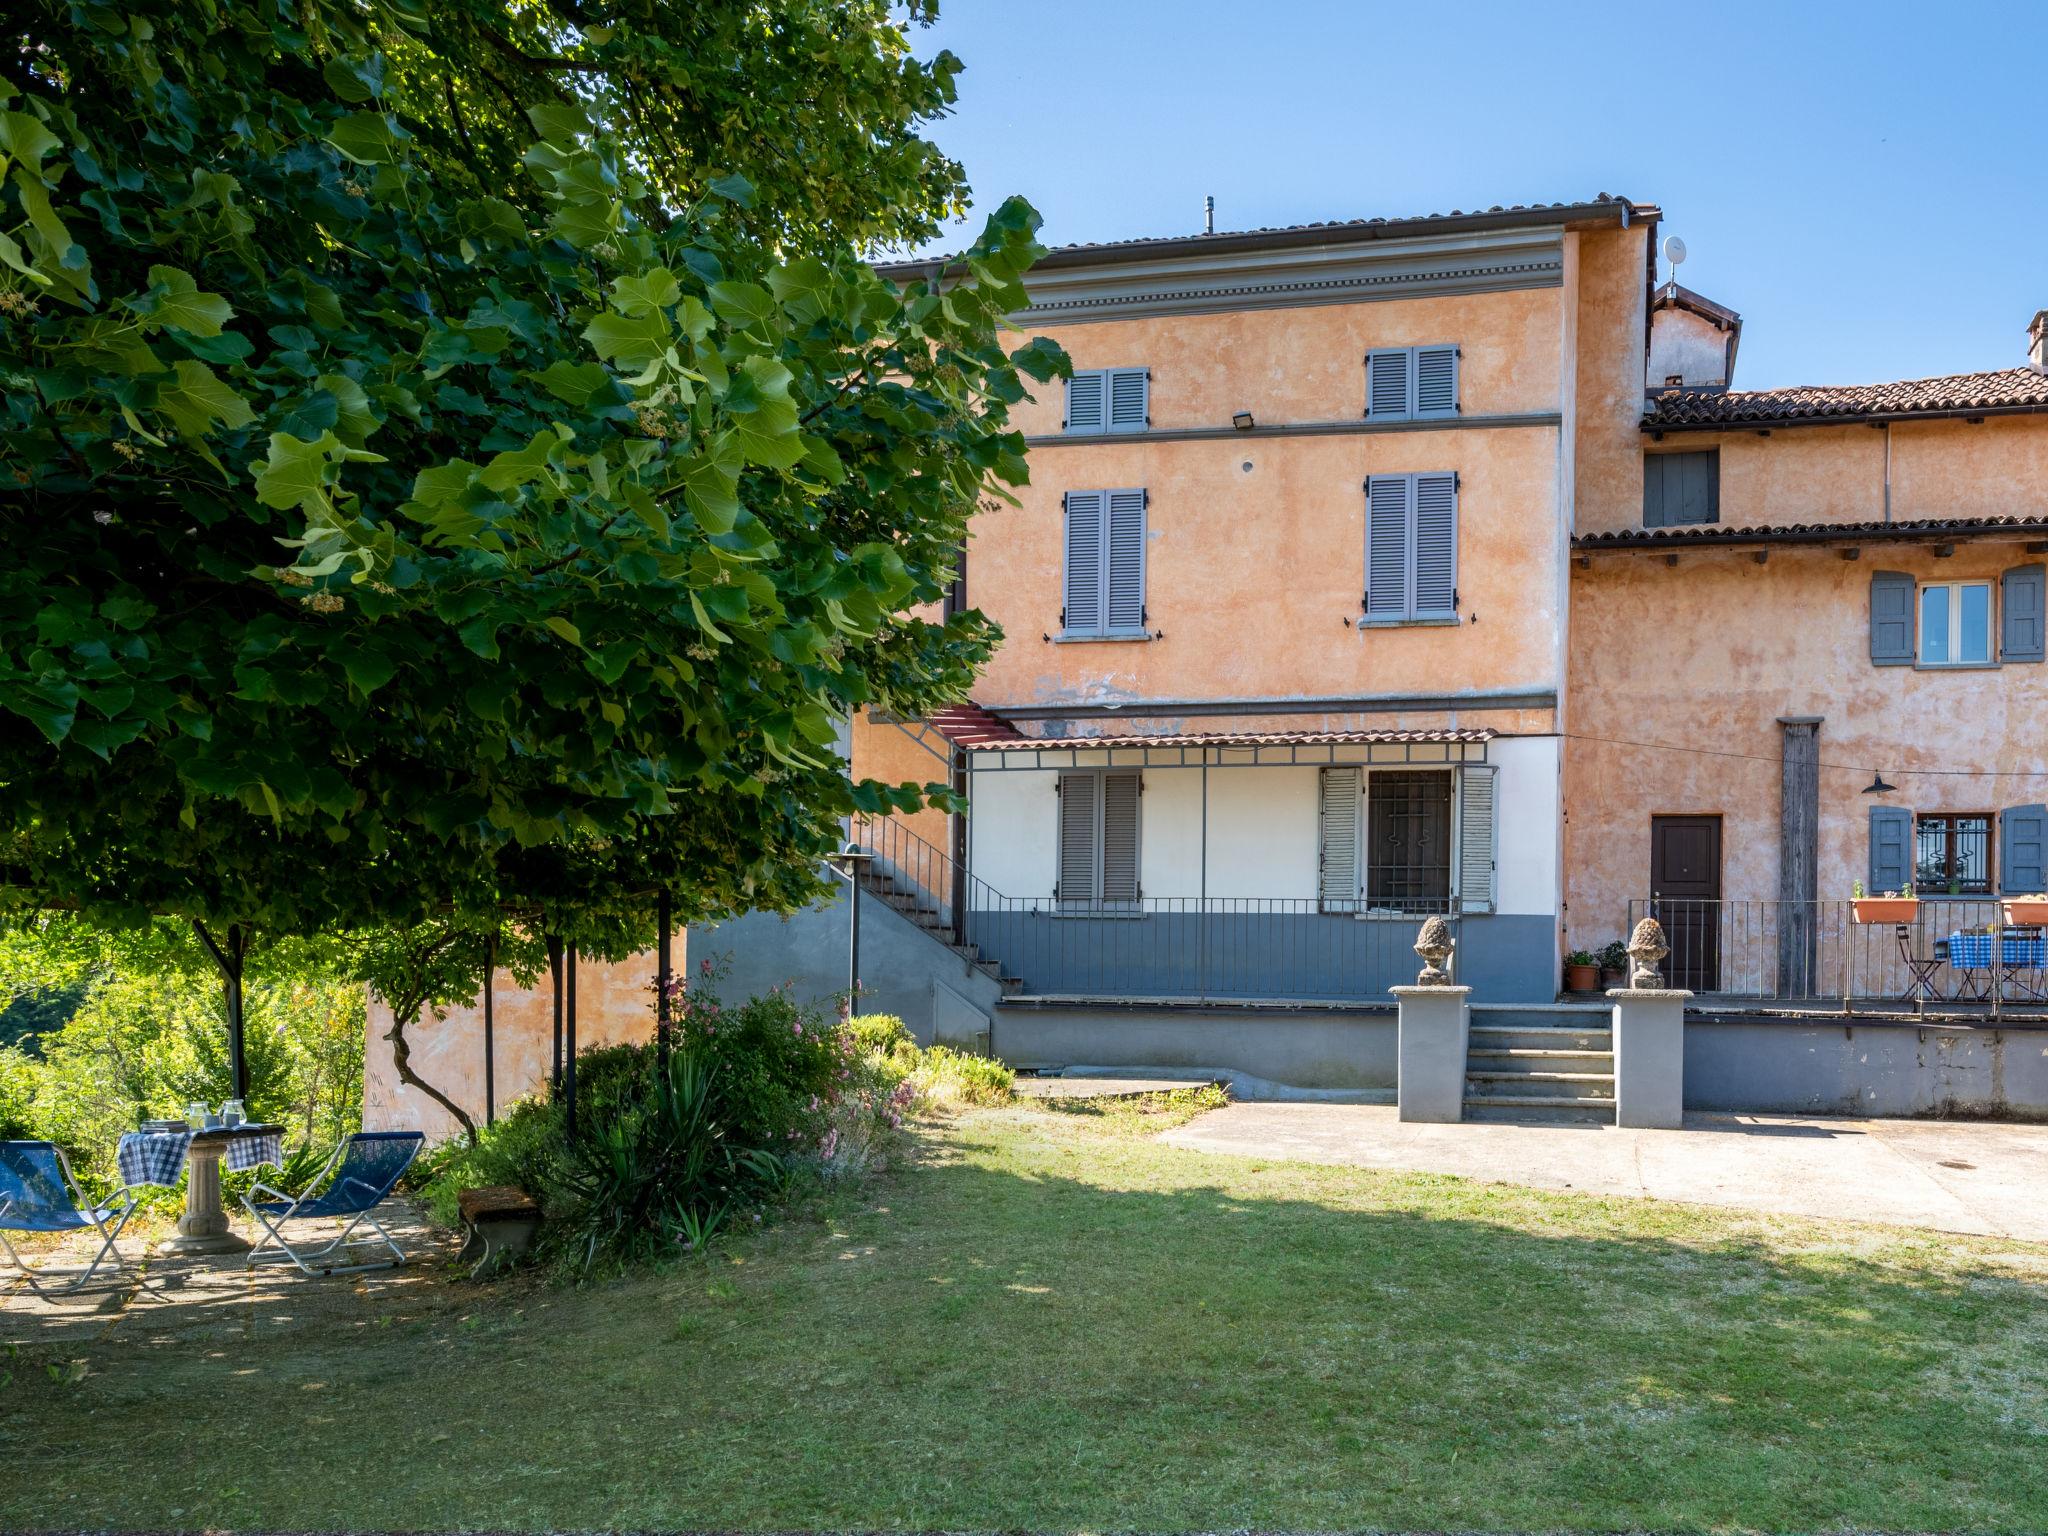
918, 0, 2048, 389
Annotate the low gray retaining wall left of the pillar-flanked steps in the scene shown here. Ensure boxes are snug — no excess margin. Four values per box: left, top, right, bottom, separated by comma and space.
993, 1004, 1395, 1087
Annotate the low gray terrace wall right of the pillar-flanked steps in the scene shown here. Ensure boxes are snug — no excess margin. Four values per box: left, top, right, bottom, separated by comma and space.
1686, 1018, 2048, 1120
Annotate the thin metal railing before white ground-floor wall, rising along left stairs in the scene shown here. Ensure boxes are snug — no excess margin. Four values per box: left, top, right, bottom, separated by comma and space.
854, 817, 1458, 1006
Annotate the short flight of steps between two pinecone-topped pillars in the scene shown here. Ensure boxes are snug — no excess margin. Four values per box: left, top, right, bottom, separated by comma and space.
1464, 1004, 1614, 1124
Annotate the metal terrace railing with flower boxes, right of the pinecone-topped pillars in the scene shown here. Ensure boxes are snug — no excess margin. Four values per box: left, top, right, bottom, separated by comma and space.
1622, 897, 2048, 1014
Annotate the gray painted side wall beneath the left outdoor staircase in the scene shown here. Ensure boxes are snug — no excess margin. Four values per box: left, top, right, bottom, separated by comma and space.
686, 885, 1001, 1051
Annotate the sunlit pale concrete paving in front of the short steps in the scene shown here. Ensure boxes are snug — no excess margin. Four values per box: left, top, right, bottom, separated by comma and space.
1163, 1104, 2048, 1243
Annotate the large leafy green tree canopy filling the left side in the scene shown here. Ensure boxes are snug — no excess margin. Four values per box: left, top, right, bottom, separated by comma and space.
0, 0, 1065, 1130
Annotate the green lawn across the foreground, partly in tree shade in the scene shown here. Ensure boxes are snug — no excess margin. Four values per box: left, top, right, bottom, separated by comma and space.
0, 1108, 2048, 1530
